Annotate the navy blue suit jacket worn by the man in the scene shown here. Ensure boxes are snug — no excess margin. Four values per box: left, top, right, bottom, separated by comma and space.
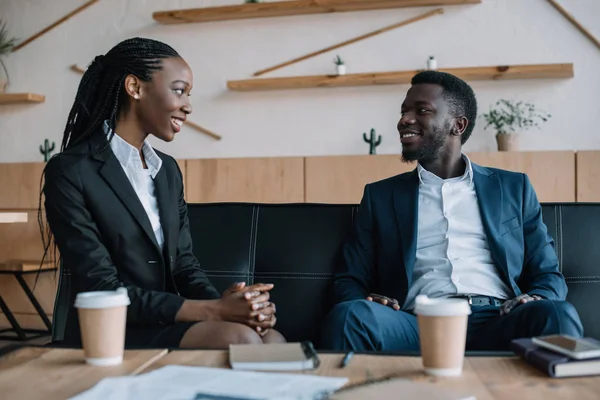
334, 164, 567, 305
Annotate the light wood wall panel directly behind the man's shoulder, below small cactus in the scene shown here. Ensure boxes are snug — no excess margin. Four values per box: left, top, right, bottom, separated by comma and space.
305, 155, 416, 204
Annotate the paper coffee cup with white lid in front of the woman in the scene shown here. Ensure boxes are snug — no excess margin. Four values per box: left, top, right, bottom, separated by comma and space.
75, 288, 130, 366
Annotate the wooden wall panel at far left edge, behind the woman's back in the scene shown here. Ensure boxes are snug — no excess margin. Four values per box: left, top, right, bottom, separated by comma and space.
0, 163, 46, 210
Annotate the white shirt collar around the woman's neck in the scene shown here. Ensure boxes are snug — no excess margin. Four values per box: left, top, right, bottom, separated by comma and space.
104, 121, 162, 179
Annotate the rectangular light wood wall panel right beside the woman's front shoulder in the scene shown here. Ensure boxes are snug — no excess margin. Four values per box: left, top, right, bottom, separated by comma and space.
187, 157, 304, 203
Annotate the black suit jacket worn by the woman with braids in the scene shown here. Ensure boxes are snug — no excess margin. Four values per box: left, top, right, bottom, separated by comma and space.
44, 134, 221, 326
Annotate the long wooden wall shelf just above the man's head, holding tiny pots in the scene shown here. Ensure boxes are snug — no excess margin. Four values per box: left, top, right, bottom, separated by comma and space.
227, 64, 573, 91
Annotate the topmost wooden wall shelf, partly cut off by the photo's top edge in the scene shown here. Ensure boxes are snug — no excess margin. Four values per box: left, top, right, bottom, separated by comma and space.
152, 0, 481, 24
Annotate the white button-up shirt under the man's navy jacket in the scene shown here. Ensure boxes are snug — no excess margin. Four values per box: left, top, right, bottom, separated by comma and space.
404, 155, 511, 310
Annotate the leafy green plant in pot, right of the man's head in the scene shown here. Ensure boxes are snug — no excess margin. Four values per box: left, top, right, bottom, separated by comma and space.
483, 99, 551, 151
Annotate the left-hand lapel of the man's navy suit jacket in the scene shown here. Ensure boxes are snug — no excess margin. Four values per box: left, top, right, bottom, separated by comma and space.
394, 169, 419, 287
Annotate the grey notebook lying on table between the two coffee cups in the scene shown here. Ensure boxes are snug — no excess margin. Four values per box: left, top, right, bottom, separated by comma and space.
229, 342, 320, 371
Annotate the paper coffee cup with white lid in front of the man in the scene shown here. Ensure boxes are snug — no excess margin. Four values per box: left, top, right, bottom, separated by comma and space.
415, 295, 471, 376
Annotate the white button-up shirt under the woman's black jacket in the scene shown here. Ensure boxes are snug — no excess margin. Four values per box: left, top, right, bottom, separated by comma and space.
104, 121, 165, 249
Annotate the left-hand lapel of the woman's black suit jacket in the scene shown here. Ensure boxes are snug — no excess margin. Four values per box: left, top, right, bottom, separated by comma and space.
92, 141, 160, 253
